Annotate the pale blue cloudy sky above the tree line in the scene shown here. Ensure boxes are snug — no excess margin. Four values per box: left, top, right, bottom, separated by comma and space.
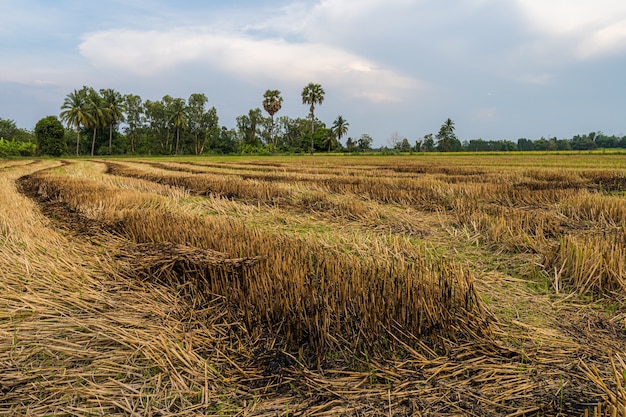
0, 0, 626, 146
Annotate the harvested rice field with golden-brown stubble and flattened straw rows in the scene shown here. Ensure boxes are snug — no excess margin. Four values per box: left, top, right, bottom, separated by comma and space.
0, 154, 626, 417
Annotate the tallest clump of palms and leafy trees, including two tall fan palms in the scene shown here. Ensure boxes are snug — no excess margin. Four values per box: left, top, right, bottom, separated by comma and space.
45, 83, 356, 156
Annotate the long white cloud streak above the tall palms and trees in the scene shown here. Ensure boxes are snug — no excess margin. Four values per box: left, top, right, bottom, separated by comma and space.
80, 28, 421, 101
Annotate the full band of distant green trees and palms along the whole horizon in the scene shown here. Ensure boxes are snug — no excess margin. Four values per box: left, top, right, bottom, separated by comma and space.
0, 83, 626, 157
